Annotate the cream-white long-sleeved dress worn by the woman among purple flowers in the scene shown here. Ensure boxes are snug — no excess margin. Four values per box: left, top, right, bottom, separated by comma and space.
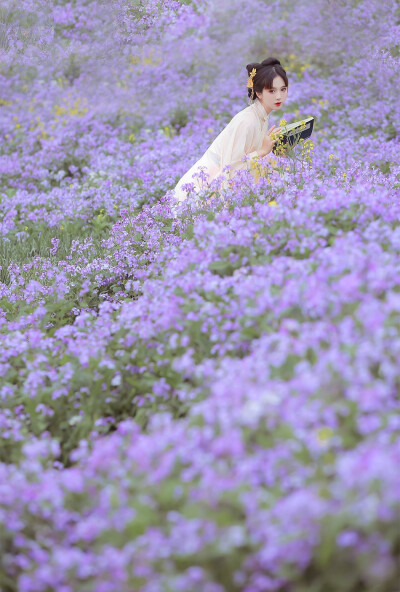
174, 99, 271, 202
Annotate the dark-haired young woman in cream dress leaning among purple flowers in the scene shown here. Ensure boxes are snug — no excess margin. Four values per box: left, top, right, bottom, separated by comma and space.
174, 58, 289, 202
